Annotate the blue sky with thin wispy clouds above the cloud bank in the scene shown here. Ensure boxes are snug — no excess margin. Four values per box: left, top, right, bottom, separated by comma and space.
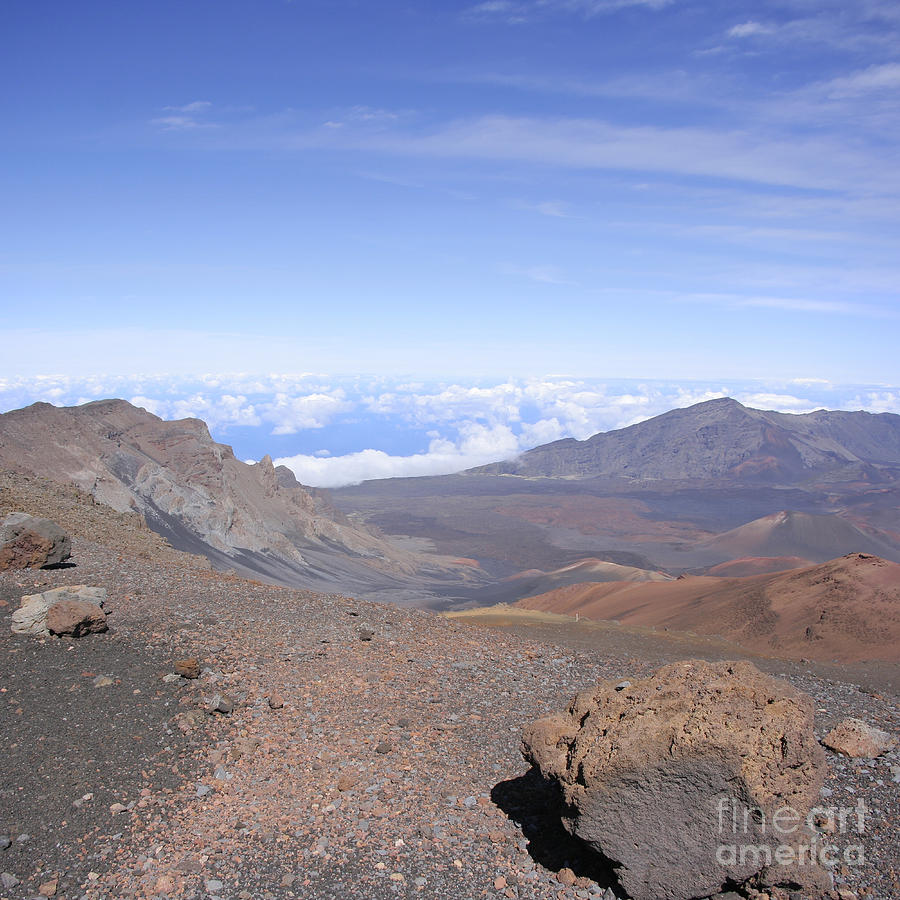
0, 0, 900, 486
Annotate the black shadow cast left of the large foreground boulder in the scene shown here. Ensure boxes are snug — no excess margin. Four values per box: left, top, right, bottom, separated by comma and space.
491, 767, 625, 897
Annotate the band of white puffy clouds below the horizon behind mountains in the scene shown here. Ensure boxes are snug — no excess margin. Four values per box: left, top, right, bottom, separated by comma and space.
0, 374, 900, 487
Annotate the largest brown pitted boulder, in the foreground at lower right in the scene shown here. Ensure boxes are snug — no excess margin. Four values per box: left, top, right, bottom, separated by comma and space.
523, 660, 827, 900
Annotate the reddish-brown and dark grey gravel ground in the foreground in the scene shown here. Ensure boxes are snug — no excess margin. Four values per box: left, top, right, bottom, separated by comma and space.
0, 539, 900, 900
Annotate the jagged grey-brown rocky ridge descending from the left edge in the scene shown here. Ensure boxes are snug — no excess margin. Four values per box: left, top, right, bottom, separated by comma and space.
0, 400, 474, 587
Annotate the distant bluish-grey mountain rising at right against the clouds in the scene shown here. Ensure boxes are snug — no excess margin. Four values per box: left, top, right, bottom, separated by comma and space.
471, 398, 900, 484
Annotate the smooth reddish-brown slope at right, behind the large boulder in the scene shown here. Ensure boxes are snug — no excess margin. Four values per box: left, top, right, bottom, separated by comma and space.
517, 553, 900, 662
